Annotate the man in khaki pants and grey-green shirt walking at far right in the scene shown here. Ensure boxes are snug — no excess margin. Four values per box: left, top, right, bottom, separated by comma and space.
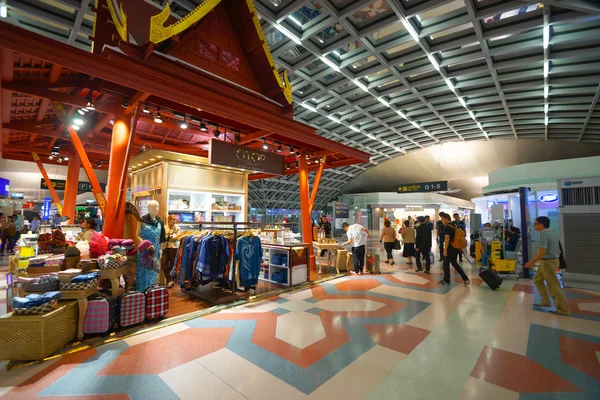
525, 217, 571, 317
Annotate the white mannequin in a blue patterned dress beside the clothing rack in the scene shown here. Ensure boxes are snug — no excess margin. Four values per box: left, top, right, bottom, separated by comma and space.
135, 200, 165, 292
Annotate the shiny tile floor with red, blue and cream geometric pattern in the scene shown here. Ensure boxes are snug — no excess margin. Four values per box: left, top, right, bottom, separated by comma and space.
0, 252, 600, 400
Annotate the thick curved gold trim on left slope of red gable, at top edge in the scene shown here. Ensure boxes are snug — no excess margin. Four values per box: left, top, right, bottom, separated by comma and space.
150, 0, 221, 44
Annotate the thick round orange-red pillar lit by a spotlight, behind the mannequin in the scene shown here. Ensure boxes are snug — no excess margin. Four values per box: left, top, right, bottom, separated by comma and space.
104, 109, 131, 238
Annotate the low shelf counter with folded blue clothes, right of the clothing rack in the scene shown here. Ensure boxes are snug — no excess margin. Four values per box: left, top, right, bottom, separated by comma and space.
259, 243, 311, 287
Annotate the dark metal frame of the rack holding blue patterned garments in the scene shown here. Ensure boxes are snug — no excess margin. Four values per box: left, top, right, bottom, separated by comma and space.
177, 221, 260, 304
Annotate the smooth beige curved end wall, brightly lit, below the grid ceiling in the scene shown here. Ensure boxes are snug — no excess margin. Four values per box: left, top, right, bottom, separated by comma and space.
342, 140, 600, 200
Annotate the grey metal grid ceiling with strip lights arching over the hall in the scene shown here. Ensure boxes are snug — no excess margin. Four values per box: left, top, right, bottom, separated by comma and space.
7, 0, 600, 209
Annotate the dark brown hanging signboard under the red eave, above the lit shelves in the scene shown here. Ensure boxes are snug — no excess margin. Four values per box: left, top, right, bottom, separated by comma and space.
208, 139, 285, 175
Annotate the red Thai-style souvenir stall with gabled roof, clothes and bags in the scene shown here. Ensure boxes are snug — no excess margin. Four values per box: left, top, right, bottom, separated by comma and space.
0, 0, 369, 360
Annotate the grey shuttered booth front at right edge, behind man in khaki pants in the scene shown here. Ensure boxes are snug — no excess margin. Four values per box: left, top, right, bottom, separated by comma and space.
558, 177, 600, 290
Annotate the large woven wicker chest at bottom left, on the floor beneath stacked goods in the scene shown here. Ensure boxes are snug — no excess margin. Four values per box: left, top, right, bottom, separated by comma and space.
0, 301, 79, 361
